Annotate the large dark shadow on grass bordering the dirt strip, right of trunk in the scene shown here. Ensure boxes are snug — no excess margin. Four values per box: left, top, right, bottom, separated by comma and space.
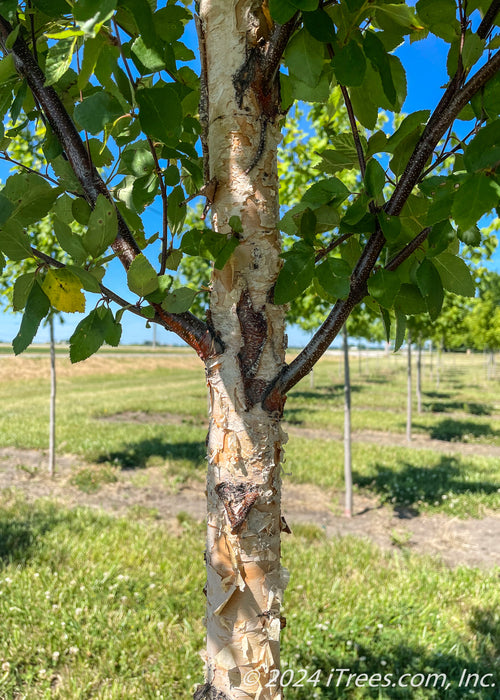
353, 455, 499, 518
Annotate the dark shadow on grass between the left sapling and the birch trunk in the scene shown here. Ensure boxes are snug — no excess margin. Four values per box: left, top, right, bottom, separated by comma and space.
96, 438, 207, 469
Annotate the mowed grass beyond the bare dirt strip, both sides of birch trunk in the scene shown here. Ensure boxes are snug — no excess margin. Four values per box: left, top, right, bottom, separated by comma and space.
0, 356, 500, 517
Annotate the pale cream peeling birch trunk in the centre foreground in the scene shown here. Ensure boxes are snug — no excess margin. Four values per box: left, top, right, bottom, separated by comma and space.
195, 0, 287, 700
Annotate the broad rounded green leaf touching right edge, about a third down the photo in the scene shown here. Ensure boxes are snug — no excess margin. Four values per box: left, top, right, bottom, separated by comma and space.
451, 173, 498, 229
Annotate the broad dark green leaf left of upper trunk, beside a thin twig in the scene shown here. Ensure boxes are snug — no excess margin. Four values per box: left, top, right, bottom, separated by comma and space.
136, 85, 182, 144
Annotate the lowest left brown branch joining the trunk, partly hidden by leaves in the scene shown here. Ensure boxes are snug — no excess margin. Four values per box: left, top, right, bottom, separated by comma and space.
31, 248, 222, 360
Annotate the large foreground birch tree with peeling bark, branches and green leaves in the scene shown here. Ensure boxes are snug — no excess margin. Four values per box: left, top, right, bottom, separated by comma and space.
0, 0, 500, 700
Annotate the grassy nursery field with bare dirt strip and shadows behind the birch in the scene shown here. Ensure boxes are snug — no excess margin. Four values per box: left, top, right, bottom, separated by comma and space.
0, 348, 500, 700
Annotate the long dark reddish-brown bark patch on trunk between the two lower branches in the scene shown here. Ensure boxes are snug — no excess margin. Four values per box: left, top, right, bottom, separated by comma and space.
236, 289, 267, 407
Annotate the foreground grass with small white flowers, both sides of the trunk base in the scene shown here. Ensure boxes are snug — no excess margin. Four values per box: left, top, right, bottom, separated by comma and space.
0, 498, 500, 700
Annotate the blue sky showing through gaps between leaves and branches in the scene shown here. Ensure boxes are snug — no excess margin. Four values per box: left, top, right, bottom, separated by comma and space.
0, 11, 500, 346
